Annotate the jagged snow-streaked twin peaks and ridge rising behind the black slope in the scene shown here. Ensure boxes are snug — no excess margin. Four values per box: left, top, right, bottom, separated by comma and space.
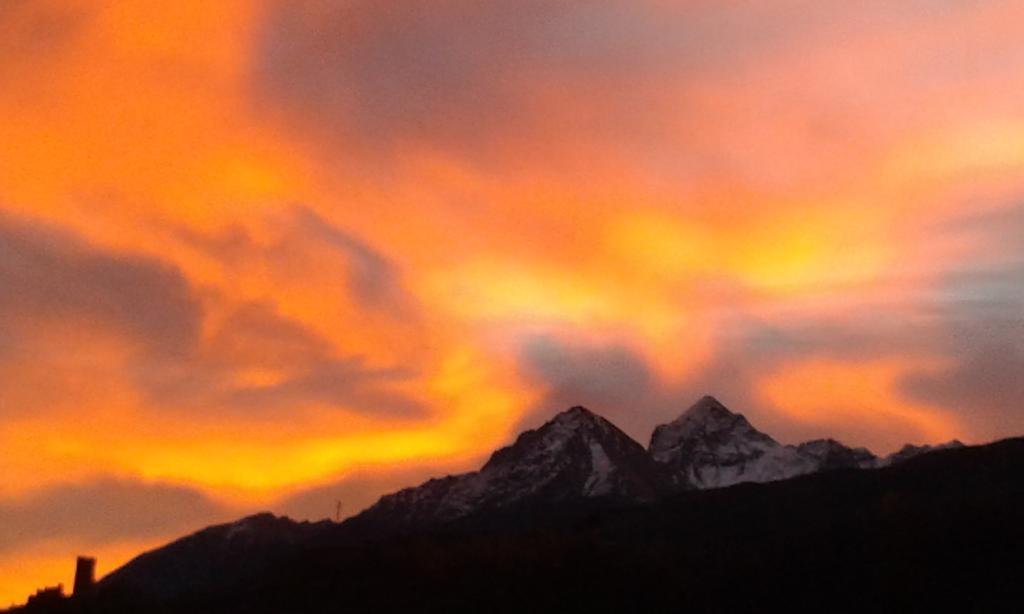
357, 396, 963, 528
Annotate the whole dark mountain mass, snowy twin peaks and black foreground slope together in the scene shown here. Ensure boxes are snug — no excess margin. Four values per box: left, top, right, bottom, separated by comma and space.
14, 397, 1024, 613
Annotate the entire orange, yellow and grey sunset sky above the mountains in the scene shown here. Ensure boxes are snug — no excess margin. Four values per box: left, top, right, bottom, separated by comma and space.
0, 0, 1024, 606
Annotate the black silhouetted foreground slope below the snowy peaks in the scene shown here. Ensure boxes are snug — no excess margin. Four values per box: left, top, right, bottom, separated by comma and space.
9, 439, 1024, 614
